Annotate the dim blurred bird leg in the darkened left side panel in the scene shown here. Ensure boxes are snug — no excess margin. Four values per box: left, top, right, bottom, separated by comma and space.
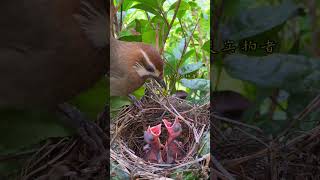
58, 103, 107, 155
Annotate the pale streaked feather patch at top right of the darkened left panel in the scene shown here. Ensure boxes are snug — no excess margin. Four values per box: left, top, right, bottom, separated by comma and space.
74, 0, 109, 48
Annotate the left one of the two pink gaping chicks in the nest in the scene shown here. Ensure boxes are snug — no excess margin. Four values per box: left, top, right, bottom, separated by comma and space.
143, 124, 163, 163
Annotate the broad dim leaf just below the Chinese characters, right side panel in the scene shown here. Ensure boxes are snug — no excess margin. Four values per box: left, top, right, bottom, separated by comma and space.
224, 54, 320, 92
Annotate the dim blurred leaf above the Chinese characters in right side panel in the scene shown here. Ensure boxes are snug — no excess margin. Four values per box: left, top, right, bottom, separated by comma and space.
222, 1, 299, 41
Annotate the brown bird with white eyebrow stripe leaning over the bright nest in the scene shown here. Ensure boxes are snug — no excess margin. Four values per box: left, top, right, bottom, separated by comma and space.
109, 2, 166, 104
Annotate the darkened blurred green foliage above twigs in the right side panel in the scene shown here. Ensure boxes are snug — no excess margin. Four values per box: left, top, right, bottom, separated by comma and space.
211, 0, 320, 134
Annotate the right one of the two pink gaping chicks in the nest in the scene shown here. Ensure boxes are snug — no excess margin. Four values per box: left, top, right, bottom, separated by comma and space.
162, 117, 186, 164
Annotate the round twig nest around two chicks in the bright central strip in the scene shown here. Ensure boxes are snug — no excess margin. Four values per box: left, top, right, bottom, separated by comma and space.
110, 84, 210, 179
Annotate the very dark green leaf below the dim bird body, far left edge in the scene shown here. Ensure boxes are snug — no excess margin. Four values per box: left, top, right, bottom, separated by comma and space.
0, 109, 70, 155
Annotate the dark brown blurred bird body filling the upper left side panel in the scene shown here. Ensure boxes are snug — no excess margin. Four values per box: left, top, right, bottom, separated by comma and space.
0, 0, 108, 106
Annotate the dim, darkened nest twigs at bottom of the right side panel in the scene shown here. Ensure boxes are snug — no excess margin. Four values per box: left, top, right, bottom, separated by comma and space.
212, 114, 320, 180
